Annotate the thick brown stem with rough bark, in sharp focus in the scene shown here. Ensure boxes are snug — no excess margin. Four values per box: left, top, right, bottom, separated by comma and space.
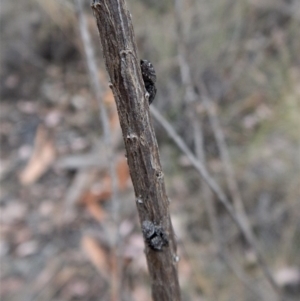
91, 0, 181, 301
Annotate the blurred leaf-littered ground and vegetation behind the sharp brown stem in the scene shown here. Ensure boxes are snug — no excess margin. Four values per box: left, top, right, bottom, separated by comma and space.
0, 0, 300, 301
